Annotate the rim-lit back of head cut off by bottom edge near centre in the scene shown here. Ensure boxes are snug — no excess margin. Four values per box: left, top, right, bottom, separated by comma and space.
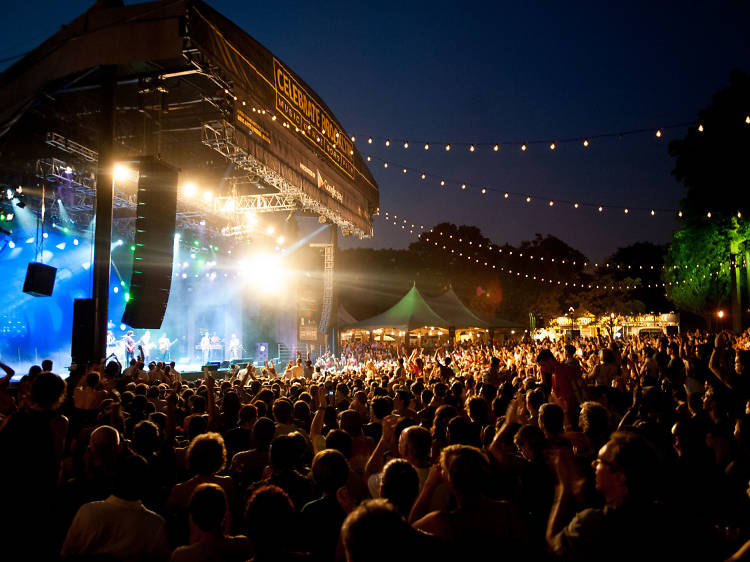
341, 499, 419, 562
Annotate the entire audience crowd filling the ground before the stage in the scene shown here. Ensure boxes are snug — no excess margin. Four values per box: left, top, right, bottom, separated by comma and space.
0, 332, 750, 562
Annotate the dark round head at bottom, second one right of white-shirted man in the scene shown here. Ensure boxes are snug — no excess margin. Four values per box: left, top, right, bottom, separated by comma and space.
245, 486, 294, 556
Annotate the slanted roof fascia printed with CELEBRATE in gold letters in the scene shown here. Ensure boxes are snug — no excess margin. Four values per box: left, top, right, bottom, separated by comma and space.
189, 2, 379, 232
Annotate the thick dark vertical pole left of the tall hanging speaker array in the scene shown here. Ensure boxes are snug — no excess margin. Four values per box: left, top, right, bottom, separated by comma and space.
91, 65, 116, 362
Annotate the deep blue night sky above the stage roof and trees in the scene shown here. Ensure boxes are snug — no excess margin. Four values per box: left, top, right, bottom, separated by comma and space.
0, 0, 750, 261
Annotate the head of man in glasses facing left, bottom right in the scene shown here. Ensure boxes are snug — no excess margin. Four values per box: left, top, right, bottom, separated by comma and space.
594, 432, 660, 504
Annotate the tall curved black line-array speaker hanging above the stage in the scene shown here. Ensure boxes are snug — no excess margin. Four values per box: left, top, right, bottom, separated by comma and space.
122, 157, 182, 329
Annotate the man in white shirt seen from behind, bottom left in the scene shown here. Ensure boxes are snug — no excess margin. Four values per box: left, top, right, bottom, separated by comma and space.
60, 456, 170, 561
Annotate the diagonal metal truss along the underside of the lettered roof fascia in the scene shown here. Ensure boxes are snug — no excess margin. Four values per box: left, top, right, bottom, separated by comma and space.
201, 120, 372, 238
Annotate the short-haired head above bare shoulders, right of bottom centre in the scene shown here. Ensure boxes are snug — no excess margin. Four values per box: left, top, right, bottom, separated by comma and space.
440, 445, 490, 504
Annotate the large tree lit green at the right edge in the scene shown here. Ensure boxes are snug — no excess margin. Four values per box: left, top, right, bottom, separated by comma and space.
663, 70, 750, 329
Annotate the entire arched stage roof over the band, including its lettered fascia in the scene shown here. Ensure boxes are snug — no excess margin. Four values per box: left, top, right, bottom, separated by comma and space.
0, 0, 379, 237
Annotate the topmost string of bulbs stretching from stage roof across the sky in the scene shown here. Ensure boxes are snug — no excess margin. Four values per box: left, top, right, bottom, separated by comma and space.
351, 115, 750, 153
